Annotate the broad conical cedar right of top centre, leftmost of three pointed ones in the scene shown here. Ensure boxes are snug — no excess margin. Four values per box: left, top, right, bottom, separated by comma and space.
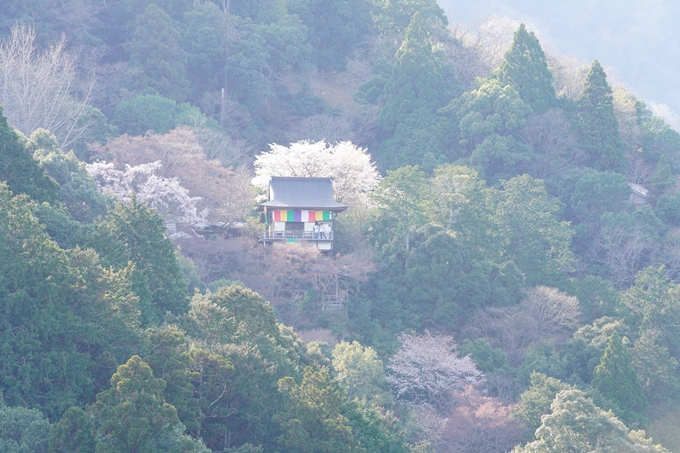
378, 12, 446, 136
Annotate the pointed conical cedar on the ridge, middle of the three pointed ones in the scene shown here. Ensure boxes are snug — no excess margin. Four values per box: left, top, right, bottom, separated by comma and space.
493, 24, 556, 113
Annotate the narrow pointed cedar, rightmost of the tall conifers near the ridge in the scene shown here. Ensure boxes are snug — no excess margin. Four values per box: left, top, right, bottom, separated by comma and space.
578, 60, 625, 173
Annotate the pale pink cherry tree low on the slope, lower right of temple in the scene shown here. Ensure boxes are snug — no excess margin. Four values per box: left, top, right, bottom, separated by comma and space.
386, 332, 485, 410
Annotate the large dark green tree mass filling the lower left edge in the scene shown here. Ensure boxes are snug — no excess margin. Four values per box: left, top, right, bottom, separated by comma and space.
0, 184, 94, 417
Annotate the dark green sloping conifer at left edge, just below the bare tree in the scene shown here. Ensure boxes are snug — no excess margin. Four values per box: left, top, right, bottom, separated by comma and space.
0, 106, 59, 203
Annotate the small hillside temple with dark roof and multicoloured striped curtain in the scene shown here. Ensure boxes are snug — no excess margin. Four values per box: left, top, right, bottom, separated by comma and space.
258, 176, 347, 252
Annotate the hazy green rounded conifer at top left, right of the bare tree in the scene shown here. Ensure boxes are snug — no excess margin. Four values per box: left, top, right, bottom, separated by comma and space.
124, 3, 188, 100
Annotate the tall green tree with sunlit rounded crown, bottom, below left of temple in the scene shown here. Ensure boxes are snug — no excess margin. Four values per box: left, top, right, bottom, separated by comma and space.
181, 286, 306, 449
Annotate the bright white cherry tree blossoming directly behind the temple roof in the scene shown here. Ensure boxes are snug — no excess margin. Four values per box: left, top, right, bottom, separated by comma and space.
253, 140, 380, 204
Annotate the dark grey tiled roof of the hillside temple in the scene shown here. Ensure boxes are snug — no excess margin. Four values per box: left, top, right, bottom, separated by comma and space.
258, 176, 347, 212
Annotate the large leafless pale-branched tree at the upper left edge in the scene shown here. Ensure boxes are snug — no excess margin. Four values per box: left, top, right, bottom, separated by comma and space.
0, 25, 94, 148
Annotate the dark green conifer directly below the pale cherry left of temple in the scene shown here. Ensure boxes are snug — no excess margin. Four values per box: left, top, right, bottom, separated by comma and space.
90, 199, 188, 325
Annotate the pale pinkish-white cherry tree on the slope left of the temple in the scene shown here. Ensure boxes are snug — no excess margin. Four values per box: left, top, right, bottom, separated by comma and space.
87, 161, 208, 223
